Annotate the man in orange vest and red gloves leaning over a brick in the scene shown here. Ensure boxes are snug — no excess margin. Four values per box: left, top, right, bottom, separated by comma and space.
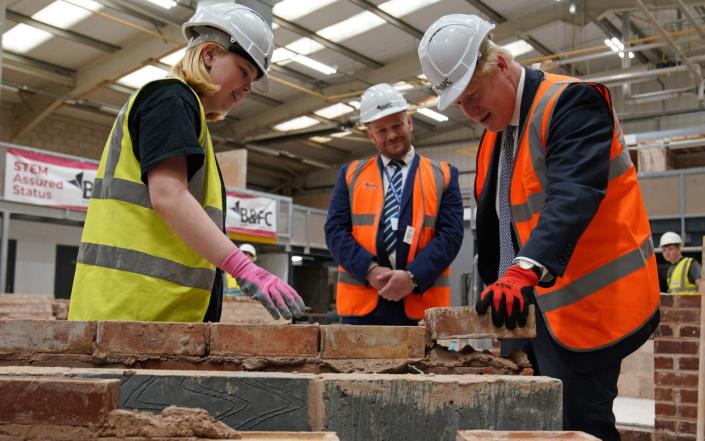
419, 15, 659, 441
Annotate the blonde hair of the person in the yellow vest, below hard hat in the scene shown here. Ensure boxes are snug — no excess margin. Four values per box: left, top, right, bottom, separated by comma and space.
171, 41, 227, 121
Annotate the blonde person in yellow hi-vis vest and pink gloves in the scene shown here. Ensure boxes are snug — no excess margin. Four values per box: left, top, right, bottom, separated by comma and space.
69, 3, 304, 322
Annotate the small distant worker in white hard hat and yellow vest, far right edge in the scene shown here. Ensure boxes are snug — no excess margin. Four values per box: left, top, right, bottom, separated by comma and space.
659, 231, 701, 294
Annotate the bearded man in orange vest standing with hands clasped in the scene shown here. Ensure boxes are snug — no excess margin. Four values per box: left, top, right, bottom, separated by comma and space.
325, 84, 463, 325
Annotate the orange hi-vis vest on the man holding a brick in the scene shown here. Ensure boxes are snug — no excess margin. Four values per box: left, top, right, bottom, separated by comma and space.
475, 74, 659, 351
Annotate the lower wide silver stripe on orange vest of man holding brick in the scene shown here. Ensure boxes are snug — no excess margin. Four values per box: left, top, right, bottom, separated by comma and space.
536, 237, 654, 314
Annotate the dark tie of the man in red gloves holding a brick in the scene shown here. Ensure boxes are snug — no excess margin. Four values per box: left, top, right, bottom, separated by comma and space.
497, 126, 516, 277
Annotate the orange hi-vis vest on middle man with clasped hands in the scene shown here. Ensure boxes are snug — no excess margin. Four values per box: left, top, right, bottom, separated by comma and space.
336, 155, 450, 319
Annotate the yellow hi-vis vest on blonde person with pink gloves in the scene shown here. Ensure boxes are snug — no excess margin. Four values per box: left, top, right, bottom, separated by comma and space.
69, 78, 224, 322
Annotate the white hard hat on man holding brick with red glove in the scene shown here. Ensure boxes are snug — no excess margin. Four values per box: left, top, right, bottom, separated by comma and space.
419, 14, 494, 110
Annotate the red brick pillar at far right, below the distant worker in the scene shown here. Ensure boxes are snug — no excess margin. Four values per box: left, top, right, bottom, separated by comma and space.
654, 295, 701, 441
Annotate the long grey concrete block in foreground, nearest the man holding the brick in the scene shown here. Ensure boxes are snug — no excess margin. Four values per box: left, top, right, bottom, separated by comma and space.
314, 374, 562, 441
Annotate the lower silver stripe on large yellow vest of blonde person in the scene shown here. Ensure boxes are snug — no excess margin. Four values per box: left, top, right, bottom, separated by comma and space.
77, 242, 215, 291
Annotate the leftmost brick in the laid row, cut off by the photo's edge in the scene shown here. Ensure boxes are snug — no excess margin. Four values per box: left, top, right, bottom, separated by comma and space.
0, 320, 96, 354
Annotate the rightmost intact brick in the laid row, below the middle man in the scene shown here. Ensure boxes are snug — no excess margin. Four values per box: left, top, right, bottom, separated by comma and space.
321, 325, 426, 359
